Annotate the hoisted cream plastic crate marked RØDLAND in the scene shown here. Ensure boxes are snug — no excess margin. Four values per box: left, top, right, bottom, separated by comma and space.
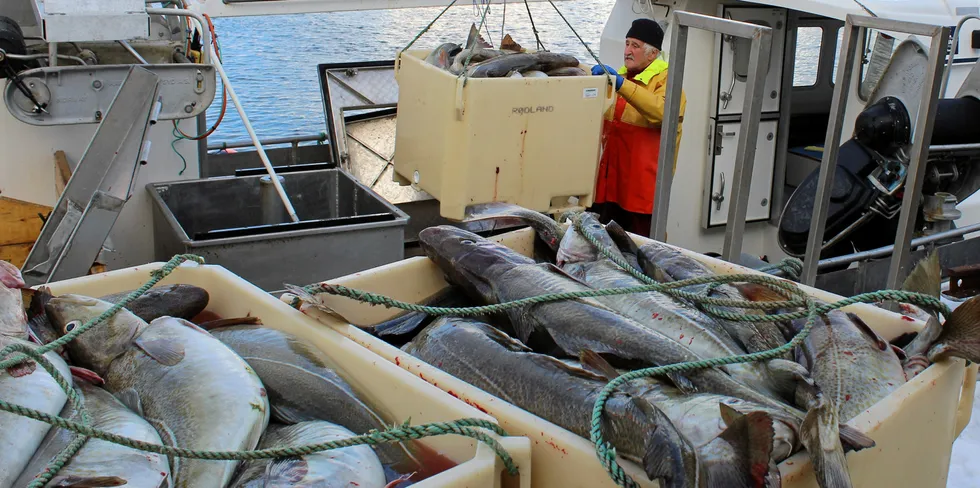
392, 50, 615, 220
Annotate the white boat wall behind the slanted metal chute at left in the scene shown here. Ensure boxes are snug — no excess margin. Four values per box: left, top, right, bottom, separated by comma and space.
0, 97, 199, 269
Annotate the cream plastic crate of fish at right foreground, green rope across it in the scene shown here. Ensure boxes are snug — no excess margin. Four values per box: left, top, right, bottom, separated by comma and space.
281, 229, 977, 488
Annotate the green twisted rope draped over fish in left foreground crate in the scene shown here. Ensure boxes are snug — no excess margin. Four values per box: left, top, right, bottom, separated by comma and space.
0, 254, 518, 480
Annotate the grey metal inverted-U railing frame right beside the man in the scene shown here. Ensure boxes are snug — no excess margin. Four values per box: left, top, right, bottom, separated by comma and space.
650, 10, 772, 261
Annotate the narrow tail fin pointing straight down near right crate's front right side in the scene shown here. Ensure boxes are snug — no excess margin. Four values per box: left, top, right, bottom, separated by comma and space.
800, 397, 851, 488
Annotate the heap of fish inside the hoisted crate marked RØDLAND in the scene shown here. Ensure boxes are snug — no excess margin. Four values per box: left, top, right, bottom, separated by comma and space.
425, 25, 589, 78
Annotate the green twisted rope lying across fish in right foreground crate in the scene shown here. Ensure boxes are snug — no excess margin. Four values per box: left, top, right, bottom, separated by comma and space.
292, 214, 950, 488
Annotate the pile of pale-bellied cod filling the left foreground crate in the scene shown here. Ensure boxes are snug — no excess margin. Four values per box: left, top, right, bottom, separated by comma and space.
0, 261, 425, 488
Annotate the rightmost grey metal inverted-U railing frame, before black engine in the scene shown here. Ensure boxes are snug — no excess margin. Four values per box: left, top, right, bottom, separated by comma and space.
801, 14, 949, 289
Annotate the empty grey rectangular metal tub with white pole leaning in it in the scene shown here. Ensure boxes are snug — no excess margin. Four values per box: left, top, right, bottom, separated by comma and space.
146, 169, 408, 292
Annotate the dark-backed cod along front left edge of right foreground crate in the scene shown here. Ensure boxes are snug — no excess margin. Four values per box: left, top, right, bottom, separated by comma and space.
405, 318, 773, 487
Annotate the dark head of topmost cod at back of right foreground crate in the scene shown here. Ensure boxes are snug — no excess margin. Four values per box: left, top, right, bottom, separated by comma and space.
419, 225, 534, 301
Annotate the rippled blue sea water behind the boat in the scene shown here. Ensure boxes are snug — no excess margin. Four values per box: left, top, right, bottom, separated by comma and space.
203, 0, 820, 145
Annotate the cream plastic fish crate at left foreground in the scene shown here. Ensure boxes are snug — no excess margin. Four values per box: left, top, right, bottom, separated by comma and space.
40, 263, 531, 488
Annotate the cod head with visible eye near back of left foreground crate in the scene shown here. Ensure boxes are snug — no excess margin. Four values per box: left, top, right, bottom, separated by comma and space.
44, 294, 147, 375
